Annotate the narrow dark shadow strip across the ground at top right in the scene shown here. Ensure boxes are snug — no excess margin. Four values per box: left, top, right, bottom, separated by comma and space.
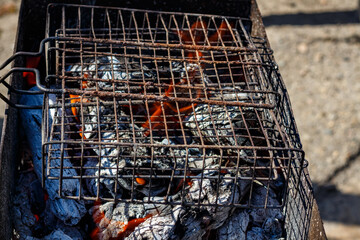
263, 10, 359, 26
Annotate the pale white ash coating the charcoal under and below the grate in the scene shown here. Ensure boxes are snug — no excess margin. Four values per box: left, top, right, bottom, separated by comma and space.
26, 53, 290, 239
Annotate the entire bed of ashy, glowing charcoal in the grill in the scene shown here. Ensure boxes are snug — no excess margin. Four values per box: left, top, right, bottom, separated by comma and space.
15, 42, 290, 239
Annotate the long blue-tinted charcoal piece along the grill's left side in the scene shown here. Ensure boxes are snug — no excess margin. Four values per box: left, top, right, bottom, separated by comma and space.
20, 87, 86, 224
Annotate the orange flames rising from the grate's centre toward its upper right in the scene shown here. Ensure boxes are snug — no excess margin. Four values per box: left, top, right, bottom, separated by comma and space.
142, 21, 233, 137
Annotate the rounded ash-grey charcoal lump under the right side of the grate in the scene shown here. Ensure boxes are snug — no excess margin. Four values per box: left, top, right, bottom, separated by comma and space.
184, 105, 253, 160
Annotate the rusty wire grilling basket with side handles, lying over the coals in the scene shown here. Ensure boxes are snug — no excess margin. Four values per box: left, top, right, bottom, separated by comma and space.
1, 1, 321, 239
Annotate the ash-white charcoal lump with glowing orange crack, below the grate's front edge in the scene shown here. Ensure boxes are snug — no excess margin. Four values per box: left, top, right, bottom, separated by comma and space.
90, 203, 184, 240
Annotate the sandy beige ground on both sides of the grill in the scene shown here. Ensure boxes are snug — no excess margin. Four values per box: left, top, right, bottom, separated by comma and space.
0, 0, 360, 240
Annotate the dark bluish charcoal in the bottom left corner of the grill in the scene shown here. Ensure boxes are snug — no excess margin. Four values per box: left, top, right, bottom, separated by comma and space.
12, 170, 83, 240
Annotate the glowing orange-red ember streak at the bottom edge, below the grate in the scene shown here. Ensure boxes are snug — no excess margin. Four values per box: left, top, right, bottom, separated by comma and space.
90, 201, 153, 240
